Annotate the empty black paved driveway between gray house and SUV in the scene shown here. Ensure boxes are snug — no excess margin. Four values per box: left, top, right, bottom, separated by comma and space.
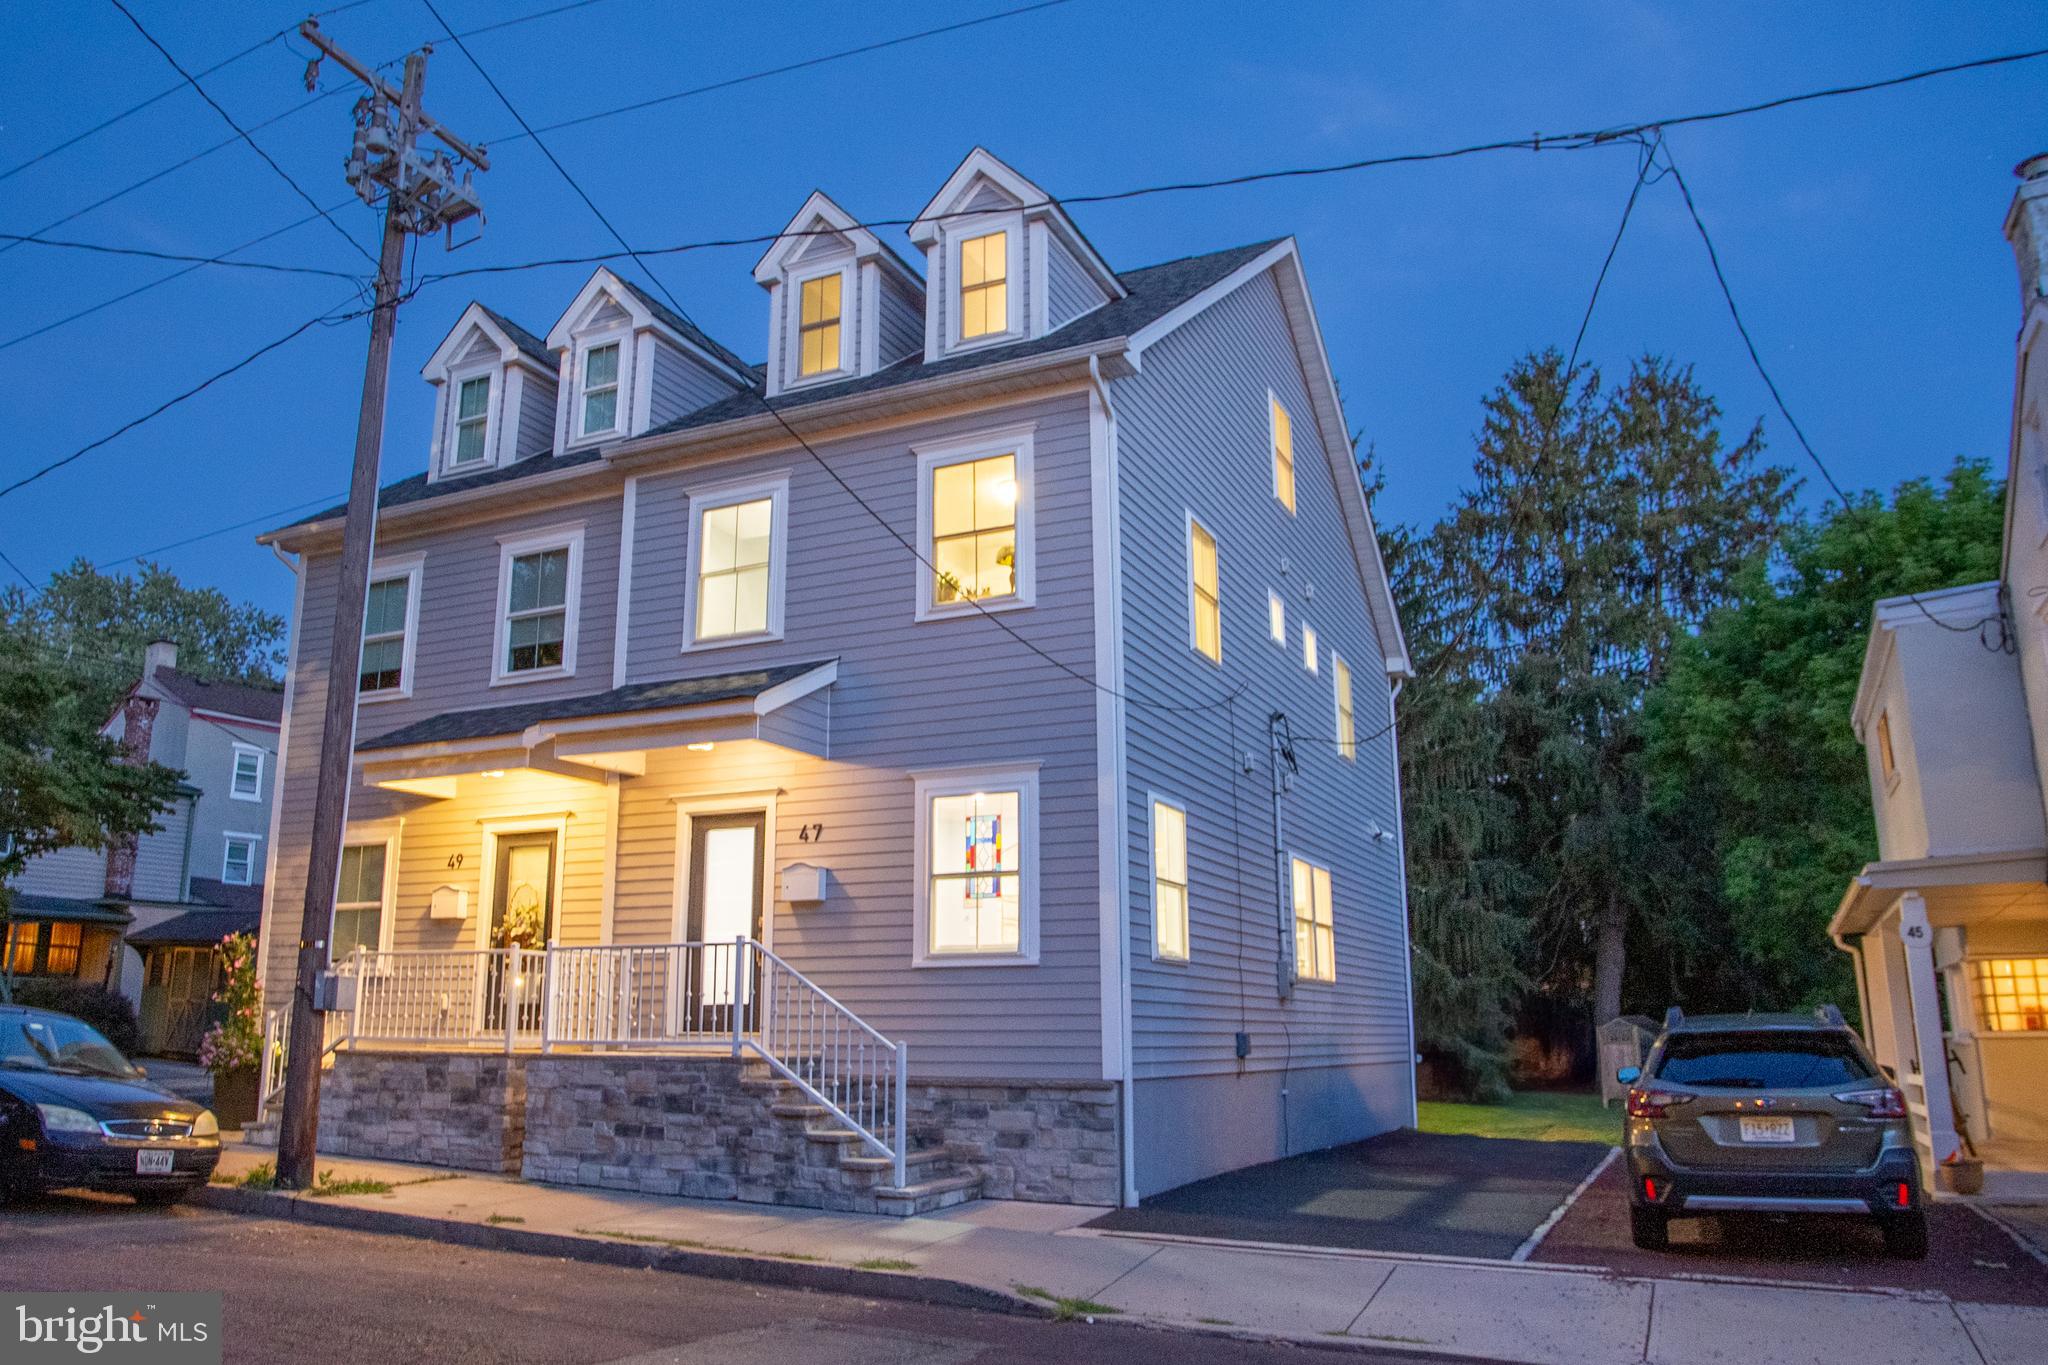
1090, 1130, 1608, 1259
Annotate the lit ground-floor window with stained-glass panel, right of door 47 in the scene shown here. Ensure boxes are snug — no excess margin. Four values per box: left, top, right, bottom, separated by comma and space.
913, 765, 1038, 966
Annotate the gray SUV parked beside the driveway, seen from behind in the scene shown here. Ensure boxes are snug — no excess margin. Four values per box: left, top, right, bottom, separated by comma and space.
1616, 1005, 1927, 1261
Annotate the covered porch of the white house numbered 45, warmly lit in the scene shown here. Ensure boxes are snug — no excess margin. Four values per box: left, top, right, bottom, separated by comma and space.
1829, 849, 2048, 1197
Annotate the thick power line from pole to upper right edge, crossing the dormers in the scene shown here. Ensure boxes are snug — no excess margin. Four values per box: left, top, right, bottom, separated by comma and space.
422, 47, 2048, 284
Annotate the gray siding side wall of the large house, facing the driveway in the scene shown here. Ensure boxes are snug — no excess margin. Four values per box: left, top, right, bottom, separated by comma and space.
1112, 274, 1409, 1193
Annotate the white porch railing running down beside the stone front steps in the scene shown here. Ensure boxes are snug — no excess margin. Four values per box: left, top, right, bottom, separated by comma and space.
321, 939, 909, 1187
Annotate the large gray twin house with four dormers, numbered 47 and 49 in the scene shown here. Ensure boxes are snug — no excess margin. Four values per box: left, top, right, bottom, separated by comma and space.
251, 149, 1415, 1212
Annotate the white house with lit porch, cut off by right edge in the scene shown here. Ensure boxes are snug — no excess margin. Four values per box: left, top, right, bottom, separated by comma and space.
1829, 156, 2048, 1191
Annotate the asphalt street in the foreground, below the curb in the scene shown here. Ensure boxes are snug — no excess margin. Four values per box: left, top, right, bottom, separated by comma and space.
0, 1195, 1474, 1365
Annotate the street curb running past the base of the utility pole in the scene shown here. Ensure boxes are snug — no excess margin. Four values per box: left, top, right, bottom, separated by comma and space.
186, 1185, 1051, 1318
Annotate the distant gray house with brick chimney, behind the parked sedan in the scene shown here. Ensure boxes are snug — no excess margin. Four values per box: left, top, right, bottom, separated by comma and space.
6, 641, 283, 1054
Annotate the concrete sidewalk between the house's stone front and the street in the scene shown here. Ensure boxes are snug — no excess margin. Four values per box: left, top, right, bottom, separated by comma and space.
201, 1148, 2048, 1365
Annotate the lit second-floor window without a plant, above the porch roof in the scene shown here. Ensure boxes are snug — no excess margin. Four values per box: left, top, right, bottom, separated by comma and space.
686, 479, 788, 649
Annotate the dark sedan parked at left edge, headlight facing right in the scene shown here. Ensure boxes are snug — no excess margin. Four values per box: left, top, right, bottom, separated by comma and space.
0, 1005, 221, 1203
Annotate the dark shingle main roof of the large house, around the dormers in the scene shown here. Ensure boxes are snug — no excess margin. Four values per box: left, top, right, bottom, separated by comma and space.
295, 237, 1280, 526
